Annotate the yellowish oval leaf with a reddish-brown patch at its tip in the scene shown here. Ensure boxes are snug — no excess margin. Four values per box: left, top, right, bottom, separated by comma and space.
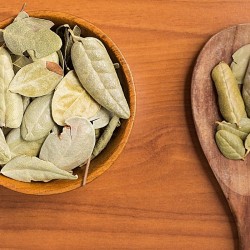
9, 61, 62, 97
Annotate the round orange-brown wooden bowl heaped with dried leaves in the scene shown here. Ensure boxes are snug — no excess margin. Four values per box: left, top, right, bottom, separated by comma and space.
0, 11, 136, 195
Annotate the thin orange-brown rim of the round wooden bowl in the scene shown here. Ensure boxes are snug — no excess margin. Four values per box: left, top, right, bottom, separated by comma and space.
0, 10, 136, 195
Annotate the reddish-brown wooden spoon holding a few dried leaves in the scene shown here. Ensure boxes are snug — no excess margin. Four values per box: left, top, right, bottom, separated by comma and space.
191, 24, 250, 250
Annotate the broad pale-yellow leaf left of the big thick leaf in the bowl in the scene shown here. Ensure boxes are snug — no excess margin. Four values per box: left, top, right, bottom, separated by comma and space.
52, 70, 100, 126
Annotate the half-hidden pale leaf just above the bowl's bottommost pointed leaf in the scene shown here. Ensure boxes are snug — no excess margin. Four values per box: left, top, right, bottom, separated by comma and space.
6, 128, 46, 158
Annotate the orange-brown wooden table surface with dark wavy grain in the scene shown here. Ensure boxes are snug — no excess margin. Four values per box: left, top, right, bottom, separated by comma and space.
0, 0, 250, 250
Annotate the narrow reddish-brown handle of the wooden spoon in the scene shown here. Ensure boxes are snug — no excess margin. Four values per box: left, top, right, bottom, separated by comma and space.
228, 193, 250, 250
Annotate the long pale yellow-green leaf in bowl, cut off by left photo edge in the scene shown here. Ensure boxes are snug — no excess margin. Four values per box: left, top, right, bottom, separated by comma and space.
0, 47, 23, 128
